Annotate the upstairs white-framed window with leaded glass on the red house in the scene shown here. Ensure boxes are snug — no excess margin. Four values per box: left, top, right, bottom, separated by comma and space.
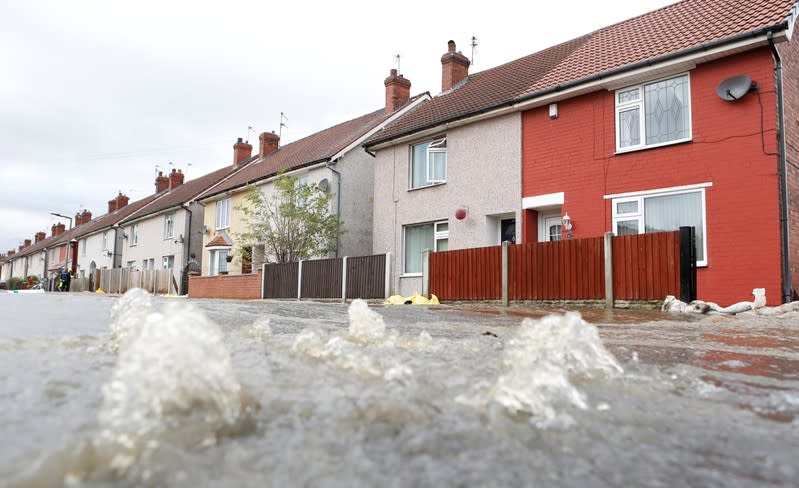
615, 73, 691, 152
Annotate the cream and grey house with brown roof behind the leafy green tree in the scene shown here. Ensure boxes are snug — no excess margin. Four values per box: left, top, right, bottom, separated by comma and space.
197, 70, 428, 276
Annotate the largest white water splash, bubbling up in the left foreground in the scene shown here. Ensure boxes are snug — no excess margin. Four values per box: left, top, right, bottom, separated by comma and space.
13, 289, 258, 486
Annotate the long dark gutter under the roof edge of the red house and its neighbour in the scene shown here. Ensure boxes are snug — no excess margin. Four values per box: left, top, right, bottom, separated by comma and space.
364, 21, 788, 149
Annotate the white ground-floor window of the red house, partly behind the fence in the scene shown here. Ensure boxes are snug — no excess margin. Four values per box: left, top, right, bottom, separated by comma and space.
612, 188, 707, 266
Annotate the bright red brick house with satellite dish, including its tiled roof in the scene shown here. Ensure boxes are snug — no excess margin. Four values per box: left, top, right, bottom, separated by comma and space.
516, 0, 799, 303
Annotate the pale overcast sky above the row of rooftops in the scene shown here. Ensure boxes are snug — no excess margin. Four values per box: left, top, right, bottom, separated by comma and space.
0, 0, 674, 253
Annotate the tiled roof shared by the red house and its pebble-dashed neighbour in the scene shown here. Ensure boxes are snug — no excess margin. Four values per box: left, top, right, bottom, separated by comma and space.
367, 0, 795, 145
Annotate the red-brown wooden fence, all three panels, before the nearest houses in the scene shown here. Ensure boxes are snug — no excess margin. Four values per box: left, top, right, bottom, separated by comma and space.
427, 231, 695, 301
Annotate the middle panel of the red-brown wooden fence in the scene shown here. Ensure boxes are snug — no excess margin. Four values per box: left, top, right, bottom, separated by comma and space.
508, 237, 605, 300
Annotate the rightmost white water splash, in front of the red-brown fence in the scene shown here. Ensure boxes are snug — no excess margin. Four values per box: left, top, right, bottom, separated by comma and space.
456, 312, 623, 428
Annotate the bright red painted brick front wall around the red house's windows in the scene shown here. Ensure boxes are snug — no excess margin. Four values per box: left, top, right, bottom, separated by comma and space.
522, 48, 781, 304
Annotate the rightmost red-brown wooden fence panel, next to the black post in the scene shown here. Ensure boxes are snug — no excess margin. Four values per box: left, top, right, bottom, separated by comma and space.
612, 231, 680, 300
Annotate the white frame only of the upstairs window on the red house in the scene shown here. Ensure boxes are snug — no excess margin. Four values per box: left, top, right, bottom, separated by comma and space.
613, 71, 693, 154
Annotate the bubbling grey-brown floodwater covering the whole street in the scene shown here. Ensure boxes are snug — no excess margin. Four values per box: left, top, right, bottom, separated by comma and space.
0, 290, 799, 487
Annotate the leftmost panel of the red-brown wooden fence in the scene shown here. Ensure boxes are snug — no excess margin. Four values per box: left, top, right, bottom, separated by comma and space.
430, 246, 502, 300
